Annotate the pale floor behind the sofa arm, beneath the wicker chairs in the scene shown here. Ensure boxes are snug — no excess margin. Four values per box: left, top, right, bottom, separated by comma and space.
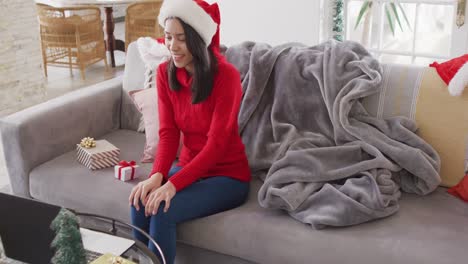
0, 22, 125, 192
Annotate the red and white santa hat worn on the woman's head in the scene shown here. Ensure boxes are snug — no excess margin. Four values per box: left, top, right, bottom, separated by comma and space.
158, 0, 221, 50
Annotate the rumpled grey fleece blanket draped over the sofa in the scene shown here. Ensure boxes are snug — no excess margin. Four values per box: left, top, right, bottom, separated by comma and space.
226, 41, 440, 228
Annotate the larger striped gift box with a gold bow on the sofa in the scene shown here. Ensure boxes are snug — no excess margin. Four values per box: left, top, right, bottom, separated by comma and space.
76, 140, 120, 170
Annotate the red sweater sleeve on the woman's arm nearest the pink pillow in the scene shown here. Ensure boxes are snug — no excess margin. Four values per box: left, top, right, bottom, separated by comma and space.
149, 64, 180, 179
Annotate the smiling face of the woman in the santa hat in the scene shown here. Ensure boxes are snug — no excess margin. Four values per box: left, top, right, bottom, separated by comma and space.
164, 18, 193, 73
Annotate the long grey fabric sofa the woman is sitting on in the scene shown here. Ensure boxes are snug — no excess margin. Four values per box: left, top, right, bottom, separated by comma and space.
0, 41, 468, 264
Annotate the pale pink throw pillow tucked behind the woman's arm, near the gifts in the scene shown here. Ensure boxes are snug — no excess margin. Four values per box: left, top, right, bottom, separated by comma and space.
129, 88, 183, 163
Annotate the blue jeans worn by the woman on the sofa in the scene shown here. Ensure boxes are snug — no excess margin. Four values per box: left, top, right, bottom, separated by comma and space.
131, 167, 249, 264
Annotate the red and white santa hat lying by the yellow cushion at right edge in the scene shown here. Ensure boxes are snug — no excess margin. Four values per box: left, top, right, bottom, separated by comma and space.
429, 54, 468, 96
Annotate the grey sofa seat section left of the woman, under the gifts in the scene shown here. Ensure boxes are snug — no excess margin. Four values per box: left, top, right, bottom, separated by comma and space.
30, 130, 152, 222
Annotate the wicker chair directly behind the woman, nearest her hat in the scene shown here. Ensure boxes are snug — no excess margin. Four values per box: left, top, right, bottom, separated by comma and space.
125, 0, 164, 50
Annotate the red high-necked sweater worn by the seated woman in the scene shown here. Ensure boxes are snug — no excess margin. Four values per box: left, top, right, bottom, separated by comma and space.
150, 57, 250, 191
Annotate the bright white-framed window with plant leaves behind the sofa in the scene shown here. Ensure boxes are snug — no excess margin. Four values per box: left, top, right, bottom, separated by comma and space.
321, 0, 468, 65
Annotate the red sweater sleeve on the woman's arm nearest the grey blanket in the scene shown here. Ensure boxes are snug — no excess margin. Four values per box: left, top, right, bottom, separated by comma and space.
168, 64, 242, 191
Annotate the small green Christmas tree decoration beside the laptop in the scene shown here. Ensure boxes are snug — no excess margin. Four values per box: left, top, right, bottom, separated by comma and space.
51, 208, 86, 264
